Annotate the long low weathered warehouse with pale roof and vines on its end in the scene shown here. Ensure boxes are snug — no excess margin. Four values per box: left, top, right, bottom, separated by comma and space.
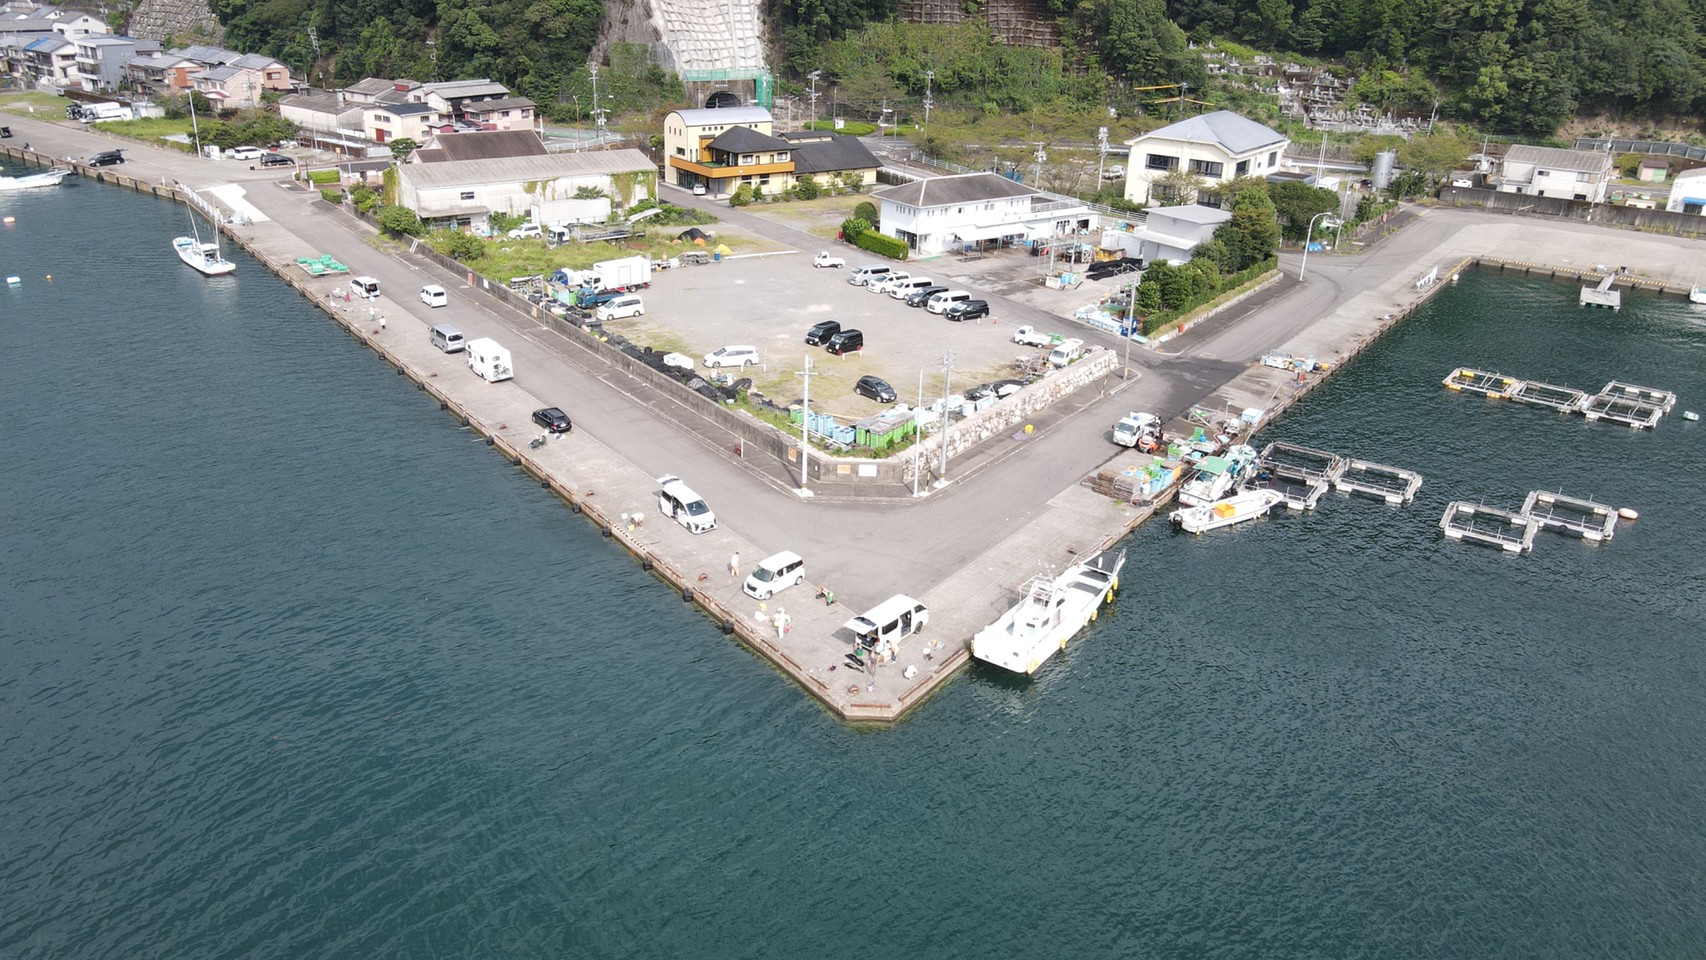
396, 150, 657, 230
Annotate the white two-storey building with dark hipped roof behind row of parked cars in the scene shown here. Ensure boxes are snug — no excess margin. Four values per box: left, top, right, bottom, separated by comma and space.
872, 174, 1097, 256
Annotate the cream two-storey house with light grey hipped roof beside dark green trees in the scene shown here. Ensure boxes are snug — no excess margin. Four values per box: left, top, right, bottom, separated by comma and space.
1126, 111, 1291, 203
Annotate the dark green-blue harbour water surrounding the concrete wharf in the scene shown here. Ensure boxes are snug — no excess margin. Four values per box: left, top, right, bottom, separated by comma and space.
0, 184, 1706, 960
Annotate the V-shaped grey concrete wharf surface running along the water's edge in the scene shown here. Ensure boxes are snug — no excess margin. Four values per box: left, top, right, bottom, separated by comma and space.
13, 118, 1706, 721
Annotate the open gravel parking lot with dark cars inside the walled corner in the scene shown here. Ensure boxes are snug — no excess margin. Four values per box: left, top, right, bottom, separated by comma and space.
604, 244, 1087, 418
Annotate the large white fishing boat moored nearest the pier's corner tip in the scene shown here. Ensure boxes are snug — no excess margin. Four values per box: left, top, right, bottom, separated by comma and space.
971, 551, 1126, 674
